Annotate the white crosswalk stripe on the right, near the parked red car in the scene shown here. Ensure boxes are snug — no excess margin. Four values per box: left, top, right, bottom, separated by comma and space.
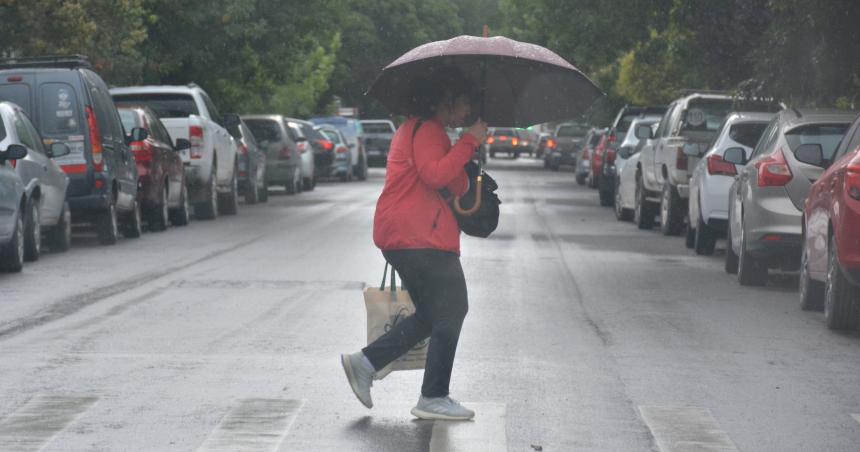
639, 406, 738, 452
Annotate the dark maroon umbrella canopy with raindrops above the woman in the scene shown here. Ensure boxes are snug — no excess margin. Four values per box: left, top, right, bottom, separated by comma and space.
367, 36, 603, 127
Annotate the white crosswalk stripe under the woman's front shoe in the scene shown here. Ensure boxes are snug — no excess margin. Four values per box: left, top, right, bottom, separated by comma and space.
430, 402, 508, 452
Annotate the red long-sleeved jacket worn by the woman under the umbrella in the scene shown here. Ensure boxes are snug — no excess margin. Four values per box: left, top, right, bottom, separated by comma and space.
373, 118, 479, 254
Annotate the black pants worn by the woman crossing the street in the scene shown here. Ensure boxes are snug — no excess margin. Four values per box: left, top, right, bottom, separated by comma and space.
362, 249, 469, 397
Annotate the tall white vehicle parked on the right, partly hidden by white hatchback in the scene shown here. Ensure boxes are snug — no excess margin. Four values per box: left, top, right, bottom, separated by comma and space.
637, 92, 781, 235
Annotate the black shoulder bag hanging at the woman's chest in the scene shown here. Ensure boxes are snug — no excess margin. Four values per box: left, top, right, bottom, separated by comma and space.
412, 120, 502, 238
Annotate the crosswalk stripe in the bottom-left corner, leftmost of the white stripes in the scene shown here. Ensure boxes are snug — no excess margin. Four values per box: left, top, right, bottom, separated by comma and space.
0, 395, 98, 452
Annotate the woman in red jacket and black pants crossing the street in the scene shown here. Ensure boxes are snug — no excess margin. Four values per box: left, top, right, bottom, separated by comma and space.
341, 68, 487, 420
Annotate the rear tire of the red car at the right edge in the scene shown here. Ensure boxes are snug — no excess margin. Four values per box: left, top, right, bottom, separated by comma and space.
824, 237, 860, 330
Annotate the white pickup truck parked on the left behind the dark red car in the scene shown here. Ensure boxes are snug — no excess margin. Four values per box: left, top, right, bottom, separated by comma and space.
111, 83, 239, 220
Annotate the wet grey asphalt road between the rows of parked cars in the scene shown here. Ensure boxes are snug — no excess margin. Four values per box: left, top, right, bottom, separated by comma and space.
0, 159, 860, 452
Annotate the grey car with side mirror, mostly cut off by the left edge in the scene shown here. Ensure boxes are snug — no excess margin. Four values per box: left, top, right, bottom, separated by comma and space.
0, 138, 32, 272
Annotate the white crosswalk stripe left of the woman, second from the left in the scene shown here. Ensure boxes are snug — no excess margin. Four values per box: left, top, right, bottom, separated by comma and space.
198, 399, 304, 452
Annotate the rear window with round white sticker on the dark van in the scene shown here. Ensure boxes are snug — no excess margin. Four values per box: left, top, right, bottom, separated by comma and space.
39, 83, 81, 135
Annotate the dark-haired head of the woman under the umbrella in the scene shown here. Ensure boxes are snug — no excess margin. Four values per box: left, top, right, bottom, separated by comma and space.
409, 66, 478, 127
